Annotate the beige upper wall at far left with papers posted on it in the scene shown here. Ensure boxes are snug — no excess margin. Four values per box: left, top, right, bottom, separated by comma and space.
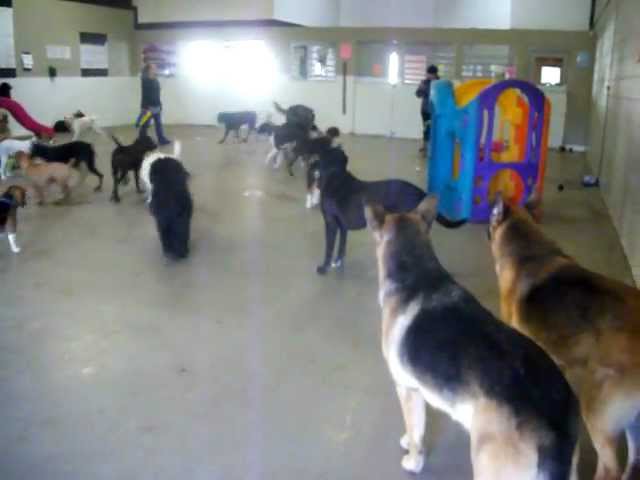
13, 0, 134, 77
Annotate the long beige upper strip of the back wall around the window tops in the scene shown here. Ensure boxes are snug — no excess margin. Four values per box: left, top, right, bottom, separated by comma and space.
135, 27, 594, 145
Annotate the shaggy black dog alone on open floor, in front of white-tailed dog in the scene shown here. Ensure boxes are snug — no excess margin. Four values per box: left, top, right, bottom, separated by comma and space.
149, 157, 193, 259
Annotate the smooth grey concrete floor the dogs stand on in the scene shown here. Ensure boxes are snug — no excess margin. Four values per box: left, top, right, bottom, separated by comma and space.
0, 127, 631, 480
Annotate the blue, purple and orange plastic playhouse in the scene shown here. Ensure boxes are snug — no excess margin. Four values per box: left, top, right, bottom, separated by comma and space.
427, 80, 551, 224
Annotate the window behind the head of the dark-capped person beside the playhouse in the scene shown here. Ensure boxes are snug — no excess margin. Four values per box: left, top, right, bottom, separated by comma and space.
402, 44, 456, 84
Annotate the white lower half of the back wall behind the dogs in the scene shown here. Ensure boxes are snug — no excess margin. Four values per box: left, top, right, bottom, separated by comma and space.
3, 76, 566, 146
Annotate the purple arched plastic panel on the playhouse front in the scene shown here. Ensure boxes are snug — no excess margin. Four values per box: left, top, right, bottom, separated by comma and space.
471, 79, 545, 223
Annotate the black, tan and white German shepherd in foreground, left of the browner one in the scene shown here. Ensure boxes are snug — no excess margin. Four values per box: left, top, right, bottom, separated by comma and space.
366, 196, 579, 480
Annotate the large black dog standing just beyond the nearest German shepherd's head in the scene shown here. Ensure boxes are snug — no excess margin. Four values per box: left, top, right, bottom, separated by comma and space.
315, 147, 426, 275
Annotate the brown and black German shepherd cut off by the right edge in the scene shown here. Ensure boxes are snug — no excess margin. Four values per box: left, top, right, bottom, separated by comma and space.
489, 195, 640, 480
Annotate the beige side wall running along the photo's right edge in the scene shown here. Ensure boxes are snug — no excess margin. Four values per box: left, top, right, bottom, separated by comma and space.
589, 0, 640, 284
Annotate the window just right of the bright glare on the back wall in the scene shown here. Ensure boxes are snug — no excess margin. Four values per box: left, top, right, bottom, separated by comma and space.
291, 43, 337, 80
